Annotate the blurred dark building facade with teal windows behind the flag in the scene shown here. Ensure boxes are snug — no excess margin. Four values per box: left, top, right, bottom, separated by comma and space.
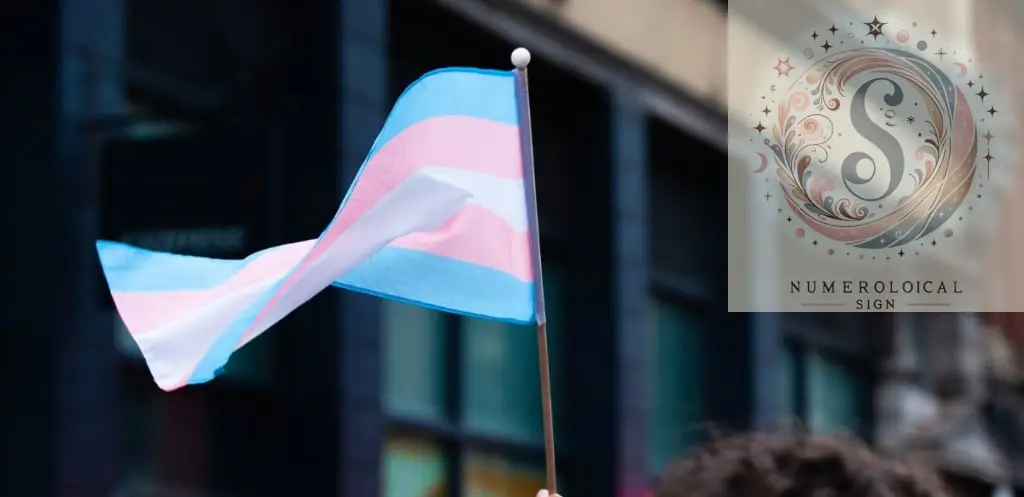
0, 0, 942, 497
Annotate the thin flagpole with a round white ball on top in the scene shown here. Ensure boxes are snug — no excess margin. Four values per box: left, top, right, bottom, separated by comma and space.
512, 47, 558, 494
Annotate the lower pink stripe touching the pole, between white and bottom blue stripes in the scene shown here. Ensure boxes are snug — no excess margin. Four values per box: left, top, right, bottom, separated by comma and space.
389, 204, 534, 282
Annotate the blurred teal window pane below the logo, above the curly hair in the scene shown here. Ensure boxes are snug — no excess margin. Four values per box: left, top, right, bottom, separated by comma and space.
807, 353, 866, 436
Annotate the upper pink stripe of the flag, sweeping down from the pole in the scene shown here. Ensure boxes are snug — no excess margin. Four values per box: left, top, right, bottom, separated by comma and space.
243, 116, 522, 340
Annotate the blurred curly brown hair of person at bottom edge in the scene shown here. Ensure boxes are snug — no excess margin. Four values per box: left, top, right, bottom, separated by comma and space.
654, 433, 952, 497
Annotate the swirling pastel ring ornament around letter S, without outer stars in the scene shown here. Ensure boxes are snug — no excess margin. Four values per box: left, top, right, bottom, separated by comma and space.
755, 37, 987, 252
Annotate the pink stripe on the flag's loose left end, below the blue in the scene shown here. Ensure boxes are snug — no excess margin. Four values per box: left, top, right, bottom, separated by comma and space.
113, 240, 313, 335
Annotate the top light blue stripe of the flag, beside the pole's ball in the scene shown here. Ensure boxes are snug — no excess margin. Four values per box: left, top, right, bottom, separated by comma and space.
367, 68, 519, 160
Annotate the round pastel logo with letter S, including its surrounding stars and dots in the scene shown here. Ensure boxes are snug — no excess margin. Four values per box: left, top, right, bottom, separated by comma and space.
748, 16, 999, 257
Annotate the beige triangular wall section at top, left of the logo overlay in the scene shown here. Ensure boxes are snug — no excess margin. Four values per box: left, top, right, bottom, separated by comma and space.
517, 0, 725, 109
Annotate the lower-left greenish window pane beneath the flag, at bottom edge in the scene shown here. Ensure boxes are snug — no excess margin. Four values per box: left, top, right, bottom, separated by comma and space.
383, 433, 447, 497
